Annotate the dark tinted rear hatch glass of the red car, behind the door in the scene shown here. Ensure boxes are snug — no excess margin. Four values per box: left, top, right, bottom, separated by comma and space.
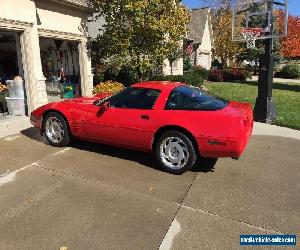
165, 86, 228, 111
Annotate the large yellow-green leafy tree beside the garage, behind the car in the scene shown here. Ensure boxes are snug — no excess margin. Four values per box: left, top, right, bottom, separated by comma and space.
91, 0, 189, 74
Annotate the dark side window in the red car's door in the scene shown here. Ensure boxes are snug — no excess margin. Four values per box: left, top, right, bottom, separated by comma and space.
109, 87, 160, 109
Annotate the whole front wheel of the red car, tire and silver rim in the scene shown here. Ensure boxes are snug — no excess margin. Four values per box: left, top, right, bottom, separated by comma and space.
44, 112, 70, 147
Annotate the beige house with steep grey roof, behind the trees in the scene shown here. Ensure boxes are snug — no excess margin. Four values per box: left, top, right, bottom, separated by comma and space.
163, 8, 213, 75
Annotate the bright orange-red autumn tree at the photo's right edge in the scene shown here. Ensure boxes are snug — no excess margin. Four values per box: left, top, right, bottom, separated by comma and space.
279, 15, 300, 57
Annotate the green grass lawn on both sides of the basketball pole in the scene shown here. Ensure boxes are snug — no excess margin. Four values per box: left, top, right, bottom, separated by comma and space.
204, 82, 300, 130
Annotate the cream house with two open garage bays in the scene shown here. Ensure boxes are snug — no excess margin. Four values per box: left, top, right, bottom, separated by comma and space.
0, 0, 93, 113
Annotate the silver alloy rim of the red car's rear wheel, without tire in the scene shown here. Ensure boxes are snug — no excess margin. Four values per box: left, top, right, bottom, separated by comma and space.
160, 137, 190, 169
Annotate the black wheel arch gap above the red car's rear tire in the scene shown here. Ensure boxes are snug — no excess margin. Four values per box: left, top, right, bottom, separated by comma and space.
151, 125, 200, 154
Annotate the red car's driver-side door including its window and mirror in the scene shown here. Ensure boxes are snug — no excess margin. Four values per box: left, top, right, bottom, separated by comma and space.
87, 87, 160, 150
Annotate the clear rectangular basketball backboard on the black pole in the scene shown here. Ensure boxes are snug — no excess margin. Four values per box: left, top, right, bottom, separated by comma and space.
232, 0, 288, 41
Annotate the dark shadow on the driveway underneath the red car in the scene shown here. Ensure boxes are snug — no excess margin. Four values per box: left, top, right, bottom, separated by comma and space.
21, 128, 218, 173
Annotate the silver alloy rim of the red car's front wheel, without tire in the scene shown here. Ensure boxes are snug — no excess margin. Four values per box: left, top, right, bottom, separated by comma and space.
45, 116, 65, 143
